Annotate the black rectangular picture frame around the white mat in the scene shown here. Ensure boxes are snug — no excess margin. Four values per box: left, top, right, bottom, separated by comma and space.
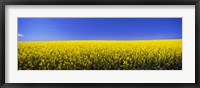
0, 0, 200, 88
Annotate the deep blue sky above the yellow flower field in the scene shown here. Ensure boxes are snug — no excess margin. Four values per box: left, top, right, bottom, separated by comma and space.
18, 18, 182, 41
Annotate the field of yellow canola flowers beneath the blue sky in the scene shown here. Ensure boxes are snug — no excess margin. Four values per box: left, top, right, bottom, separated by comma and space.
18, 39, 182, 70
